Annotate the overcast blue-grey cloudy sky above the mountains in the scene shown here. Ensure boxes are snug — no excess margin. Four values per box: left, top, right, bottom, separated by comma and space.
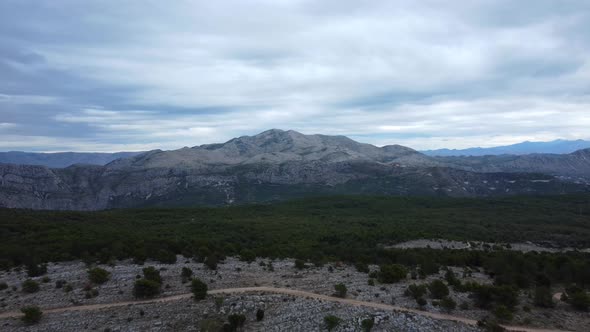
0, 0, 590, 151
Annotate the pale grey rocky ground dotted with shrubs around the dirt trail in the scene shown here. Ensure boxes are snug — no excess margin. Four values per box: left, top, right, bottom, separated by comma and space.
0, 256, 590, 331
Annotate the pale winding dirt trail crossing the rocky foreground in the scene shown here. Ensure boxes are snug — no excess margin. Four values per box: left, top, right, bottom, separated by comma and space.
0, 287, 563, 332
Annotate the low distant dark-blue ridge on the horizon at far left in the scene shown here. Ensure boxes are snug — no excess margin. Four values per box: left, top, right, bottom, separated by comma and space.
0, 151, 142, 168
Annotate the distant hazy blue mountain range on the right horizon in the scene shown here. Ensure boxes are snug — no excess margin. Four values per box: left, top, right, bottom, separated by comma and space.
420, 139, 590, 157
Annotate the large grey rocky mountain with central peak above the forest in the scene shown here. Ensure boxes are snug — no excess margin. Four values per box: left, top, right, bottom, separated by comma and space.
0, 129, 590, 210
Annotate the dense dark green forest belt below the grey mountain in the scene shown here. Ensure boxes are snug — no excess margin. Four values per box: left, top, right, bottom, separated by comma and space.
0, 195, 590, 283
